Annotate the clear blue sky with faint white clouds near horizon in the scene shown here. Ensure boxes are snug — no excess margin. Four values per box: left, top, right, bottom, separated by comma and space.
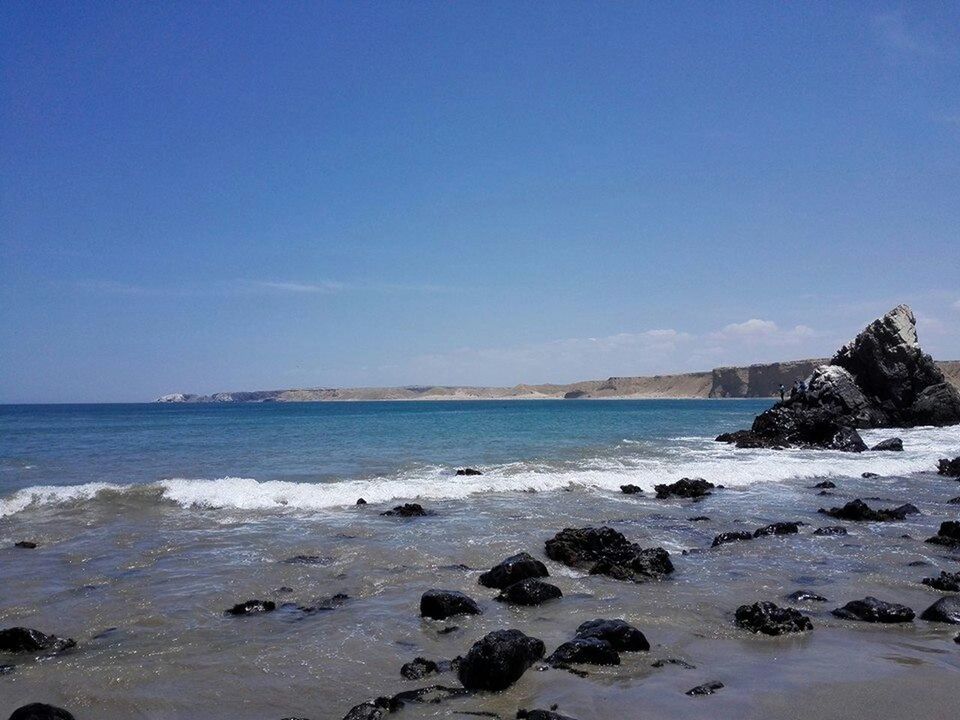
0, 0, 960, 403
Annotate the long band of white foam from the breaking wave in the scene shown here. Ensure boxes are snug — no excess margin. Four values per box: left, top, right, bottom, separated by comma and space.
0, 426, 960, 517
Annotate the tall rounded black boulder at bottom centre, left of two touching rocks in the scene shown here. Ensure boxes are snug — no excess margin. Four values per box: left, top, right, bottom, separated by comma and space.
458, 630, 545, 690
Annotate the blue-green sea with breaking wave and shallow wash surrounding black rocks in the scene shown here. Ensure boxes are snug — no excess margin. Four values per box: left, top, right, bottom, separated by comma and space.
0, 402, 960, 720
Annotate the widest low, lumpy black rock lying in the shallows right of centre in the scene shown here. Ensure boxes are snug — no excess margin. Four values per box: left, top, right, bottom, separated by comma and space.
546, 527, 673, 582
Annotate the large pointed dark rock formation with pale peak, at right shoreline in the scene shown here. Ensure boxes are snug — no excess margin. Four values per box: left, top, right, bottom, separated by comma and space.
717, 305, 960, 452
